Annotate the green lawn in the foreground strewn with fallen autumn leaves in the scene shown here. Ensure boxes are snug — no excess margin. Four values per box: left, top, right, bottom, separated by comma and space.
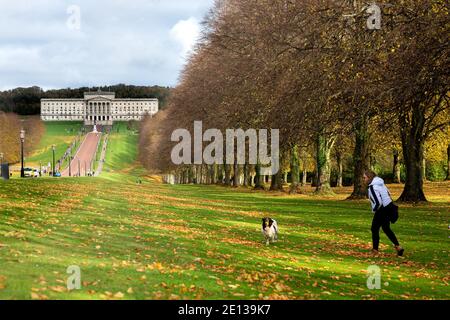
0, 173, 450, 299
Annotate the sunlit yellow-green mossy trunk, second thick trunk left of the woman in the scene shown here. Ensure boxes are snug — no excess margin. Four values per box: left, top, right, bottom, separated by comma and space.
315, 135, 335, 193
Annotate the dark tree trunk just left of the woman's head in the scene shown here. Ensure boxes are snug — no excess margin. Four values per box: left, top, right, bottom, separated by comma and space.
349, 116, 370, 199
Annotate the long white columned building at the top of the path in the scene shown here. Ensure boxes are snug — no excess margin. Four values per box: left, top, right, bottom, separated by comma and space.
41, 91, 159, 125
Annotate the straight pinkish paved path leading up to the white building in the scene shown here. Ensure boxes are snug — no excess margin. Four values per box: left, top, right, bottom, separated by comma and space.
61, 132, 102, 177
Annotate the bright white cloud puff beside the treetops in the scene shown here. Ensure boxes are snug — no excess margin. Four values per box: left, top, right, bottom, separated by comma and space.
170, 17, 200, 61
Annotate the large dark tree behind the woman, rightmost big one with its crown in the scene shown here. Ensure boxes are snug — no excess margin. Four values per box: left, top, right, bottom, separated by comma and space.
384, 0, 450, 202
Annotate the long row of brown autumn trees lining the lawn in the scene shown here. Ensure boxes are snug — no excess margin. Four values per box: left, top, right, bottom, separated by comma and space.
140, 0, 450, 202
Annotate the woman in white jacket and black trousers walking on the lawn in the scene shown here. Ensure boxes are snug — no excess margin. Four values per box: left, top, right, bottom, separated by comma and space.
364, 170, 405, 257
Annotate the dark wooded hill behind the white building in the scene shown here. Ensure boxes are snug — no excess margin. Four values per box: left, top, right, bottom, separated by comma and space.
0, 84, 171, 115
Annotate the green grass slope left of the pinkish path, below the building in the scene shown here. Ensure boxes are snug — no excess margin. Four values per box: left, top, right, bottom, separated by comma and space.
25, 122, 82, 167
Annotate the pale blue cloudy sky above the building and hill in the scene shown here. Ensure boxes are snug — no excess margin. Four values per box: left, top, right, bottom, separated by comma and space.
0, 0, 214, 90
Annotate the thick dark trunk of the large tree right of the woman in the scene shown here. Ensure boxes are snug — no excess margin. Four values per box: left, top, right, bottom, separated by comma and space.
399, 107, 427, 202
